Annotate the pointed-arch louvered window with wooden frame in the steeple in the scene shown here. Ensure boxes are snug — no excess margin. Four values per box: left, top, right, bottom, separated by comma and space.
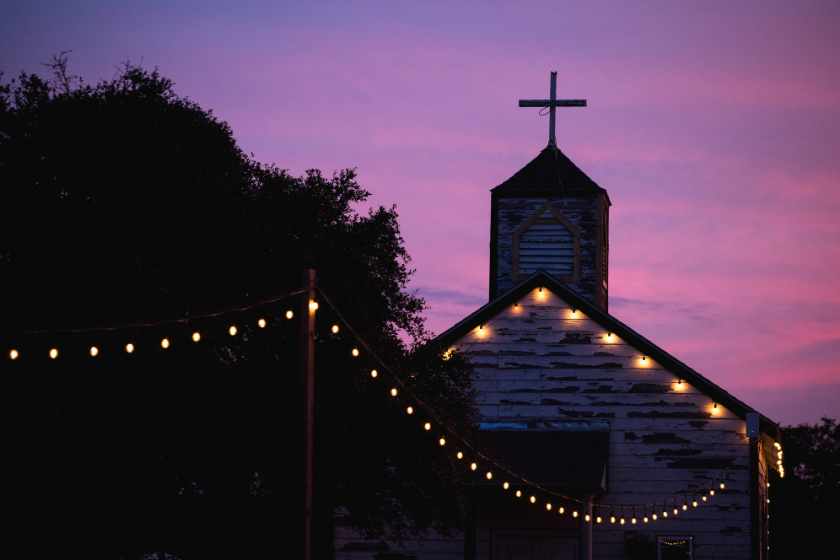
513, 202, 580, 282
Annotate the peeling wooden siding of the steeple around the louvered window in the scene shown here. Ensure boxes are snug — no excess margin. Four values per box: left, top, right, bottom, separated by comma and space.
494, 197, 598, 302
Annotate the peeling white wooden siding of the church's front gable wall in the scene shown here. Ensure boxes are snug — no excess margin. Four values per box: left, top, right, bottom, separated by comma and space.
336, 286, 751, 560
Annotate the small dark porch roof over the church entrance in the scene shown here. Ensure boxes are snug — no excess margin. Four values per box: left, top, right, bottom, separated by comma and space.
476, 430, 610, 492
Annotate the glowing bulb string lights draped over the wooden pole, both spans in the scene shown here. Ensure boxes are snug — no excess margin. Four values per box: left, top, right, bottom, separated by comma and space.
4, 287, 784, 524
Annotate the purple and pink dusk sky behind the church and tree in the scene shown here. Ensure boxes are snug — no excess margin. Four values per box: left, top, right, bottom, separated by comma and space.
0, 0, 840, 424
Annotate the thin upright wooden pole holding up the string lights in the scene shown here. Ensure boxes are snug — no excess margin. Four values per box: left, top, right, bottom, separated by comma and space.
298, 251, 317, 560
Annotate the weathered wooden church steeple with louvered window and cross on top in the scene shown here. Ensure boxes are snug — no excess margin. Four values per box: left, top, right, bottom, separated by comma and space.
490, 72, 610, 311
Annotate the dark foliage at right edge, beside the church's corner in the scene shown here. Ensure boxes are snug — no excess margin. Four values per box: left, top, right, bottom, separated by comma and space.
768, 417, 840, 558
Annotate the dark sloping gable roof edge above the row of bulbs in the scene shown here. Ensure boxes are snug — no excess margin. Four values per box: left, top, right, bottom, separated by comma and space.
437, 271, 778, 437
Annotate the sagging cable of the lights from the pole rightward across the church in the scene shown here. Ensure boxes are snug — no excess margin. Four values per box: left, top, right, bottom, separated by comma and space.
316, 286, 751, 508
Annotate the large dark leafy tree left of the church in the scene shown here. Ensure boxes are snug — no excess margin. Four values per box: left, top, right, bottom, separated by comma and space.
0, 56, 476, 558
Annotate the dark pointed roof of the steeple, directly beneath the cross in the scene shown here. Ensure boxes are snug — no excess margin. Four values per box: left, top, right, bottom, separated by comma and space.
492, 146, 606, 195
